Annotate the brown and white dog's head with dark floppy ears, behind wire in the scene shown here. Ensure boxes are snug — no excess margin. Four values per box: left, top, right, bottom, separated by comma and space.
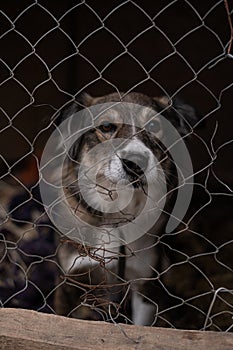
53, 93, 197, 230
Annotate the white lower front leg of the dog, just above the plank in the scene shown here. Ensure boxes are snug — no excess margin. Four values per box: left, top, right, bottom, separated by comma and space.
132, 291, 157, 326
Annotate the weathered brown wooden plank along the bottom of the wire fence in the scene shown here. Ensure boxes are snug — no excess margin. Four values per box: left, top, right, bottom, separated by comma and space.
0, 308, 233, 350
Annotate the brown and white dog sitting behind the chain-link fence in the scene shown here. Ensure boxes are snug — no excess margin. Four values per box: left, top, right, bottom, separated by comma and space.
51, 92, 198, 325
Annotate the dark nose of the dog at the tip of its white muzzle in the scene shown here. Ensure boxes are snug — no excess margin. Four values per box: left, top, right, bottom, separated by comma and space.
121, 152, 148, 176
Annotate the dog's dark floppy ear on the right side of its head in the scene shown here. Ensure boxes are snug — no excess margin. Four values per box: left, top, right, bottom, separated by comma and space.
154, 96, 201, 136
